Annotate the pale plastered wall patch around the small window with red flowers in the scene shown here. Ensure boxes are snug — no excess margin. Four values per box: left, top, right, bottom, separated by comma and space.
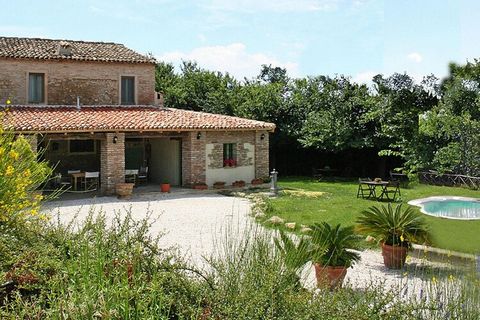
205, 143, 255, 186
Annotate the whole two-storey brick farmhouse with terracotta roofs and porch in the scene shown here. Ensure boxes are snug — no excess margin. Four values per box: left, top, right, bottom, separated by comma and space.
0, 37, 275, 194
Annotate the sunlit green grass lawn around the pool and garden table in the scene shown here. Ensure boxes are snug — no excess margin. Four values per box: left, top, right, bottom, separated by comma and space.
272, 177, 480, 253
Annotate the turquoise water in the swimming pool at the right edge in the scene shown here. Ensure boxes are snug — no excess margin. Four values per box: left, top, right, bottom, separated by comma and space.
422, 199, 480, 219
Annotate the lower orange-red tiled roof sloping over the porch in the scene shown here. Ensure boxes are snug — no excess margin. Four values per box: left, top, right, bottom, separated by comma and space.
1, 105, 275, 132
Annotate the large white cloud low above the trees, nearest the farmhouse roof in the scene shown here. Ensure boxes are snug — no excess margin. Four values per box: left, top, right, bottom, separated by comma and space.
156, 43, 298, 80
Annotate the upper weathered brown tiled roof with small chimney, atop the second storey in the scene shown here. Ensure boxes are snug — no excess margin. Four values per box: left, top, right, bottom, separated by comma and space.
0, 37, 155, 63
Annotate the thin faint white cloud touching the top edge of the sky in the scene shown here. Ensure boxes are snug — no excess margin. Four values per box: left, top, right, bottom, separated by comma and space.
201, 0, 338, 12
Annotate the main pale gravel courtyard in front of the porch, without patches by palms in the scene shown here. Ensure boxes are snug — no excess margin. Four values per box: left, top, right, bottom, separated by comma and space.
43, 193, 251, 267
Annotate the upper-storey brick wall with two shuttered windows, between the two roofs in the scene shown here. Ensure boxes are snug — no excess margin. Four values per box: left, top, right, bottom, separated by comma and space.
0, 59, 155, 105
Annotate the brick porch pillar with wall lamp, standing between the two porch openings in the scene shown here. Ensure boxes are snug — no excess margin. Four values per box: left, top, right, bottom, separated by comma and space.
100, 133, 125, 195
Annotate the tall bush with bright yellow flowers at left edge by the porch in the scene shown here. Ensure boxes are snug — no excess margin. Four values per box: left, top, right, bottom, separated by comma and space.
0, 117, 51, 225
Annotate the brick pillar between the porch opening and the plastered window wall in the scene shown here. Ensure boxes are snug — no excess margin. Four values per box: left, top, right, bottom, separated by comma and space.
182, 131, 207, 186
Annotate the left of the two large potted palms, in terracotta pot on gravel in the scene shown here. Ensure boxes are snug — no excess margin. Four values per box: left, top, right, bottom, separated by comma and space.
310, 222, 360, 289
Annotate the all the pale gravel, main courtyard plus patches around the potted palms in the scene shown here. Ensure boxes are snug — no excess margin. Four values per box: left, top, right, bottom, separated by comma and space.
43, 193, 450, 295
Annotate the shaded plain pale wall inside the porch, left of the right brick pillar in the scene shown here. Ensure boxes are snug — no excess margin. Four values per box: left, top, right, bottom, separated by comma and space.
149, 138, 181, 186
